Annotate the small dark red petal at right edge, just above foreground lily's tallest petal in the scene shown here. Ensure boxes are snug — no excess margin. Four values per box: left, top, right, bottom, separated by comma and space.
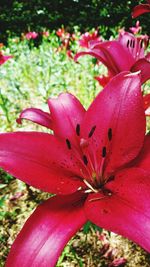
131, 58, 150, 84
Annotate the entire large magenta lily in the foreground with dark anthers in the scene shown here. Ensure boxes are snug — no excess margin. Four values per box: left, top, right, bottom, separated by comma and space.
0, 72, 150, 267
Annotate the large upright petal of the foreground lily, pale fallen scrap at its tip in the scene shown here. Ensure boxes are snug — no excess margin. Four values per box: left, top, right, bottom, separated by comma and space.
81, 72, 145, 175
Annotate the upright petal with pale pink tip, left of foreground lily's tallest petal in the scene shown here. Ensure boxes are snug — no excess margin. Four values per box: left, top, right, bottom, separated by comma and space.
48, 93, 85, 147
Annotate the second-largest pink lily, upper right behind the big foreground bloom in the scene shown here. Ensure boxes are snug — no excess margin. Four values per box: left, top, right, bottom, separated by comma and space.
74, 32, 150, 86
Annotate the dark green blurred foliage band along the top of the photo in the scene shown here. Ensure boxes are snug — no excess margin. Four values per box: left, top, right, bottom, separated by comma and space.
0, 0, 150, 42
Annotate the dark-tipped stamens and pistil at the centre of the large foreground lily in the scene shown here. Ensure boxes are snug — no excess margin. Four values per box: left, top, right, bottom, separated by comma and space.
66, 124, 114, 194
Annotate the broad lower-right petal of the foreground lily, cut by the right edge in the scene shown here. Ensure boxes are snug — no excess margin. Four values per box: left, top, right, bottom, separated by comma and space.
85, 168, 150, 252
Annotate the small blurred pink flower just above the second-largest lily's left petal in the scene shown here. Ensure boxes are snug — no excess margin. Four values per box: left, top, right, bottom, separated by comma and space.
79, 30, 102, 48
